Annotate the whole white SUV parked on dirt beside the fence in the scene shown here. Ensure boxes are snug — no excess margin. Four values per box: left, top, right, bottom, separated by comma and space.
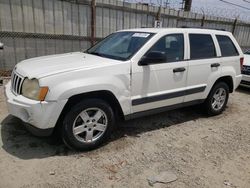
5, 28, 243, 150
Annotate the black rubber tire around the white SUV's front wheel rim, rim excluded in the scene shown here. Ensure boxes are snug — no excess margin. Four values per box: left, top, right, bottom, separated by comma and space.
62, 99, 115, 151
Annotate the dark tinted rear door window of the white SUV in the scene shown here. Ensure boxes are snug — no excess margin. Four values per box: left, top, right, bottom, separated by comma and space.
189, 34, 216, 59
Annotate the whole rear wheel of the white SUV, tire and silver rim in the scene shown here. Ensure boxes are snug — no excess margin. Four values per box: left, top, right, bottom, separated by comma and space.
204, 82, 229, 116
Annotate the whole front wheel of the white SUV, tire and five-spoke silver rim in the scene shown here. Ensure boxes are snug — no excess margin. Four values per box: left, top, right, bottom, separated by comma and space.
62, 99, 115, 151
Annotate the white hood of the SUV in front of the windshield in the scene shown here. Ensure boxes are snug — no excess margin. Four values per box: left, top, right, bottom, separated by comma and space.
15, 52, 119, 79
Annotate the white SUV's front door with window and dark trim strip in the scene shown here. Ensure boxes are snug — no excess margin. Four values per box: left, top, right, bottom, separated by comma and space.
131, 33, 188, 113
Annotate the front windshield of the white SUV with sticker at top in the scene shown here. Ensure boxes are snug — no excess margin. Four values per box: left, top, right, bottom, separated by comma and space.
85, 31, 153, 60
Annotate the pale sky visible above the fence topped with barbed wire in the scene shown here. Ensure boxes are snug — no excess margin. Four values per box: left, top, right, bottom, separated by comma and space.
125, 0, 250, 22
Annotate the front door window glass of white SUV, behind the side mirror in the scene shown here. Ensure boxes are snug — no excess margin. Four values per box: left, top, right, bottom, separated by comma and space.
148, 34, 184, 62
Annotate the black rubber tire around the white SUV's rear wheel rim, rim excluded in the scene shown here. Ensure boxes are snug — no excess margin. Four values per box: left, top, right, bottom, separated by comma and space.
205, 82, 229, 115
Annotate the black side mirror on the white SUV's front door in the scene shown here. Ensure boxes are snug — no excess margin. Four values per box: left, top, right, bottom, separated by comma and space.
138, 51, 167, 66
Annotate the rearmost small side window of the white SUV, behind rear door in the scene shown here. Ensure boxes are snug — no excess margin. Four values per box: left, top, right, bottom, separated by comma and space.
216, 35, 239, 57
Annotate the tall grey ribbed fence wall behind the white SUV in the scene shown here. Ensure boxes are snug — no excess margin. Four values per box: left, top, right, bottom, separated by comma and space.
0, 0, 250, 70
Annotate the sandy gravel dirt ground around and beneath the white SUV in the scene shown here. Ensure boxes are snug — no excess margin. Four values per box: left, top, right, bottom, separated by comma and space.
0, 81, 250, 188
